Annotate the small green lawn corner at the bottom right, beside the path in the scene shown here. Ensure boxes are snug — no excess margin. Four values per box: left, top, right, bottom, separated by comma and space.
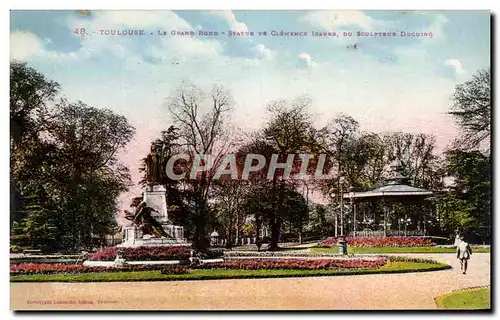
436, 287, 491, 309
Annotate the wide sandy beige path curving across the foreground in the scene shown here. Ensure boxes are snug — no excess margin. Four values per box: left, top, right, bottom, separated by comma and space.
10, 253, 490, 310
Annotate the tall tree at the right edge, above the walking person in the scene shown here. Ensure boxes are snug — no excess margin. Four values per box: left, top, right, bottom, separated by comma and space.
438, 68, 491, 242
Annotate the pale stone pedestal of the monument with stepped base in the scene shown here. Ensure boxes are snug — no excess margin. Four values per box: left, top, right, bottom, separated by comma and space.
118, 185, 191, 247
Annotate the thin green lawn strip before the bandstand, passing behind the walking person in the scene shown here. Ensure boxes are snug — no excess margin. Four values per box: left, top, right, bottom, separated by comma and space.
311, 247, 490, 254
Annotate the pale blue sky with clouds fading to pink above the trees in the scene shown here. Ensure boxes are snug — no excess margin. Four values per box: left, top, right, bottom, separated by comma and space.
11, 11, 490, 215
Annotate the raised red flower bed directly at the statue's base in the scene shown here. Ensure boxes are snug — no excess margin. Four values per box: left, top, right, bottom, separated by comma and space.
89, 246, 223, 261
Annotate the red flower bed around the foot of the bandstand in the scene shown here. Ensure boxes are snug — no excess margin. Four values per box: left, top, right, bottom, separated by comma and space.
319, 237, 436, 247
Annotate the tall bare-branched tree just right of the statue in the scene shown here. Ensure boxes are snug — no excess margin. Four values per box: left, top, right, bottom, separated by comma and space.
167, 83, 233, 250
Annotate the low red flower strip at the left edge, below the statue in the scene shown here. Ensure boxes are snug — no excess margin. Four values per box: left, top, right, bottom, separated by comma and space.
10, 263, 164, 275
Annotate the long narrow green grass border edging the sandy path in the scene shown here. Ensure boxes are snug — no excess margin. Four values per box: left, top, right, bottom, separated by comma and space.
10, 261, 450, 282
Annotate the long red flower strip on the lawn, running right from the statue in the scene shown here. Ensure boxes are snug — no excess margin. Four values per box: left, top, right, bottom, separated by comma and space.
194, 257, 387, 270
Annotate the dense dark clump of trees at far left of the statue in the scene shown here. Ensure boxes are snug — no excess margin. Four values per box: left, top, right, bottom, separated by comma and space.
11, 63, 134, 250
